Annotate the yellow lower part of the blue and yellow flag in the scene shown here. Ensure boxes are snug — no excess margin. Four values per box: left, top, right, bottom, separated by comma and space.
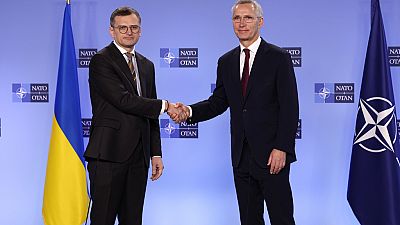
42, 116, 89, 225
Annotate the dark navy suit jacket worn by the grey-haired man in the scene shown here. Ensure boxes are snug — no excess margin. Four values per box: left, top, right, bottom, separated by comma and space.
188, 40, 299, 168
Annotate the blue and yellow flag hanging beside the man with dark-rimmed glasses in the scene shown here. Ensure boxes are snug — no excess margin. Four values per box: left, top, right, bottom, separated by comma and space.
42, 3, 89, 225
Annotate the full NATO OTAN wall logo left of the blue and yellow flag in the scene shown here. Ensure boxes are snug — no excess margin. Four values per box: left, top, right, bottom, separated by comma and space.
12, 83, 49, 103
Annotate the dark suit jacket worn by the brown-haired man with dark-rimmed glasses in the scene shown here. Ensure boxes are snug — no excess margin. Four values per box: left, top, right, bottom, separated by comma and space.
84, 43, 162, 166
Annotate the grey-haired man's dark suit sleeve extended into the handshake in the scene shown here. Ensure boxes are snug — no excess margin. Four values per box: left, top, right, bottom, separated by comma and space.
188, 56, 229, 123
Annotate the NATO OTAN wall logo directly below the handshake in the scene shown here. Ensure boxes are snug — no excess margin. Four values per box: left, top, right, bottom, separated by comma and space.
160, 119, 199, 138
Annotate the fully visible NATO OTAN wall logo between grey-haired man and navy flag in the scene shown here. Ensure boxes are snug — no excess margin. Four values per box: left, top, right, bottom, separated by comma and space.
314, 83, 354, 103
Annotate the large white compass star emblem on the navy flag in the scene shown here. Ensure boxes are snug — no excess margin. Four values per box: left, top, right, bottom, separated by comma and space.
354, 97, 397, 153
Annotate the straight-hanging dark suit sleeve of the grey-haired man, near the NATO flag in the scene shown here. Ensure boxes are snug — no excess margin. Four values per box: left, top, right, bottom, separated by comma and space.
275, 53, 299, 154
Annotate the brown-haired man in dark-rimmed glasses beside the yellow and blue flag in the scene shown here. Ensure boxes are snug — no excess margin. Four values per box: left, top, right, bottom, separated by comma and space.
85, 7, 178, 225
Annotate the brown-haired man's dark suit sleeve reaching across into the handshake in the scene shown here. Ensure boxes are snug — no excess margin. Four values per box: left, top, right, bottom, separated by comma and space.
89, 54, 162, 119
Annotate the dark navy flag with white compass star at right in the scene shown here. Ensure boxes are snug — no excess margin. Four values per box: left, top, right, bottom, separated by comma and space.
347, 0, 400, 225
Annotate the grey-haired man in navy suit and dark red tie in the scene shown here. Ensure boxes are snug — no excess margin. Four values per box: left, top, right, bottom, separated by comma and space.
173, 0, 299, 225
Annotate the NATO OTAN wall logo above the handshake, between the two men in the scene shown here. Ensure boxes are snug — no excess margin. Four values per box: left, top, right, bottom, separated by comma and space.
160, 48, 199, 68
